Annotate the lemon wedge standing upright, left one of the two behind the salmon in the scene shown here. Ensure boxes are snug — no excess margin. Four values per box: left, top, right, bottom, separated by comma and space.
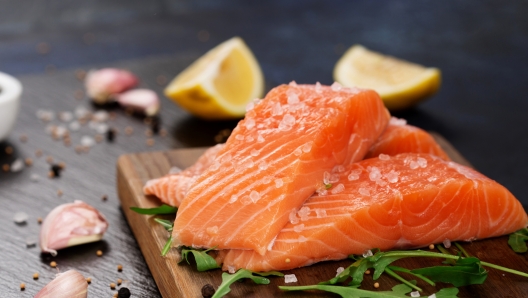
165, 37, 264, 120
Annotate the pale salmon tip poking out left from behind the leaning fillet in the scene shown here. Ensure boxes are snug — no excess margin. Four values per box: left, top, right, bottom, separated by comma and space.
143, 144, 224, 207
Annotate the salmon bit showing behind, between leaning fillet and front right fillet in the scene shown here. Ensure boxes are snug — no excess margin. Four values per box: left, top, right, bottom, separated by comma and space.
365, 117, 451, 160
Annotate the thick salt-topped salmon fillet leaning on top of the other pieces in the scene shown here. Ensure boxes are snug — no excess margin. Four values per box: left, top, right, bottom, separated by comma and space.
172, 84, 390, 254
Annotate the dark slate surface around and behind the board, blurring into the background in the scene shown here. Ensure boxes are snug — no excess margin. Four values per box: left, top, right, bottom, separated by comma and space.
0, 0, 528, 297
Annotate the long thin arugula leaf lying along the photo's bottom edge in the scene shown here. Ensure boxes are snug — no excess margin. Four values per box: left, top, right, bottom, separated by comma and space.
279, 284, 412, 298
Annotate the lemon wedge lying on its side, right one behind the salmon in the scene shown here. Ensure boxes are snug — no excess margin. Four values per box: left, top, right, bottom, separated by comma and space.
334, 45, 440, 111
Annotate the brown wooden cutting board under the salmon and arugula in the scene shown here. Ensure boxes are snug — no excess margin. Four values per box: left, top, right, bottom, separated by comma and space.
117, 134, 528, 298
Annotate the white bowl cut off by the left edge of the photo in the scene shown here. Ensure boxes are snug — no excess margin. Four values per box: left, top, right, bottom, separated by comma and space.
0, 72, 22, 141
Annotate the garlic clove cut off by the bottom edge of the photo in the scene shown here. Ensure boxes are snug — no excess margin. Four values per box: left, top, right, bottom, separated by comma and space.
34, 270, 88, 298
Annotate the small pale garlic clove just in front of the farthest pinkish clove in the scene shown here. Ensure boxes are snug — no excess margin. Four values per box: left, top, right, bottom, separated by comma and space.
116, 89, 160, 116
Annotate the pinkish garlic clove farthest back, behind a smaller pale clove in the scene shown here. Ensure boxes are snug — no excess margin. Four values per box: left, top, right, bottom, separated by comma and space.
84, 68, 139, 104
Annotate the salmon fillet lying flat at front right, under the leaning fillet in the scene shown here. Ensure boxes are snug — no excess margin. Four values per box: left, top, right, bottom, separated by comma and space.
217, 153, 528, 271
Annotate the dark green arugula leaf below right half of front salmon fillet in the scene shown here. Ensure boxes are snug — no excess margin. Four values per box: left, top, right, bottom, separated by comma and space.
411, 258, 488, 287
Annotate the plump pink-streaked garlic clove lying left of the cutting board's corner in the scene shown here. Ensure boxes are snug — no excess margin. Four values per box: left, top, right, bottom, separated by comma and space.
40, 201, 108, 256
